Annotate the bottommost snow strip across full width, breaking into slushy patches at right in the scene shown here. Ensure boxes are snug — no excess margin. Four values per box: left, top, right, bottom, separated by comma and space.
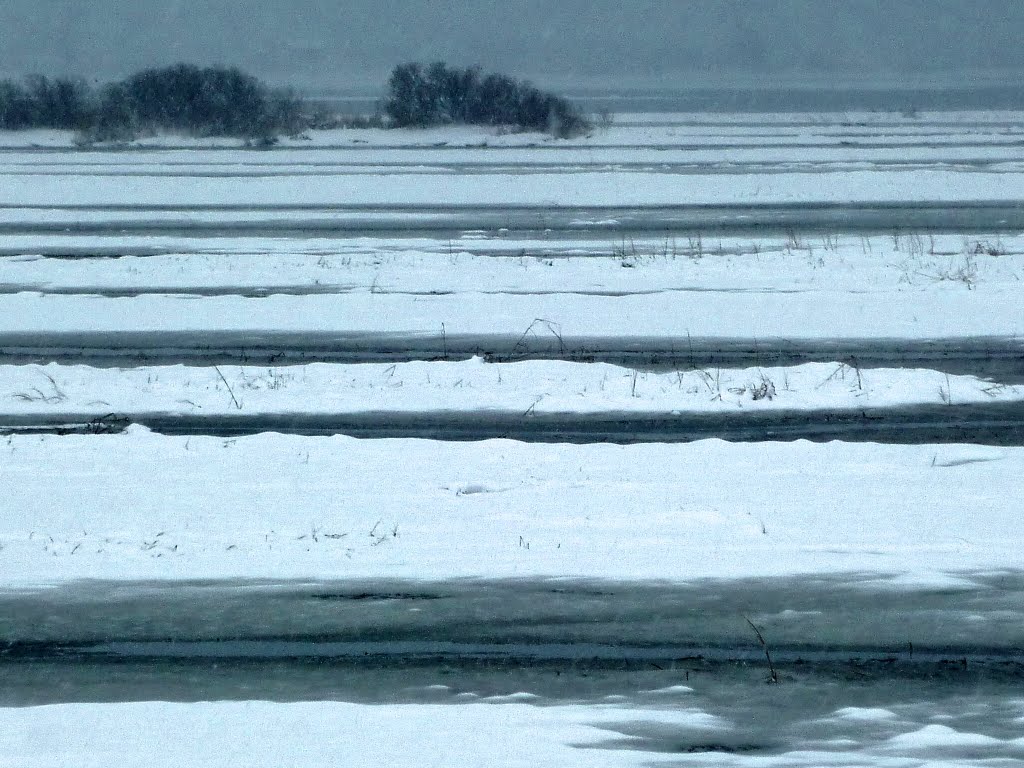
6, 691, 1024, 768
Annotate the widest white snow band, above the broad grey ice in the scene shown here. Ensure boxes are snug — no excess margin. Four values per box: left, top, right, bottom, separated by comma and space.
0, 427, 1024, 587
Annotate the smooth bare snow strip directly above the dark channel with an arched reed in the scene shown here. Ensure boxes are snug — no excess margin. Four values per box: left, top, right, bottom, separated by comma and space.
0, 286, 1024, 339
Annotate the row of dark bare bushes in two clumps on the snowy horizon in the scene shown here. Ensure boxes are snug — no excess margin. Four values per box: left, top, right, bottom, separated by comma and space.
0, 62, 591, 142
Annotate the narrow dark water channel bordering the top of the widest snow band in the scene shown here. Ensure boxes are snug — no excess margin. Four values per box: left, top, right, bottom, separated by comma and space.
0, 402, 1024, 446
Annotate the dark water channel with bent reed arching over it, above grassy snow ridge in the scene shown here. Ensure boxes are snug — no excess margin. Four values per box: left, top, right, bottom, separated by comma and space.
0, 331, 1024, 384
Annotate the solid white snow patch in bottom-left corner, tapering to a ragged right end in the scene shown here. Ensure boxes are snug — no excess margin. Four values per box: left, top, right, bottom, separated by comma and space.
0, 701, 714, 768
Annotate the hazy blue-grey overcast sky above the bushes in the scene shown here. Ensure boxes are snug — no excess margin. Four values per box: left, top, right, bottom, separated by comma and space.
0, 0, 1024, 88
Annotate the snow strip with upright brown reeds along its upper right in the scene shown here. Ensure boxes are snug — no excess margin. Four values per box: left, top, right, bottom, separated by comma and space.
0, 233, 1024, 302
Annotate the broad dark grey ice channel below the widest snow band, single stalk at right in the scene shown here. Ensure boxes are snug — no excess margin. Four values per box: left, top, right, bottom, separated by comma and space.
0, 572, 1024, 706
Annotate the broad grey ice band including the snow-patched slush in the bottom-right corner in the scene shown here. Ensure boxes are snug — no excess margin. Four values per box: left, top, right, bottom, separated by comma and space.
0, 572, 1024, 765
